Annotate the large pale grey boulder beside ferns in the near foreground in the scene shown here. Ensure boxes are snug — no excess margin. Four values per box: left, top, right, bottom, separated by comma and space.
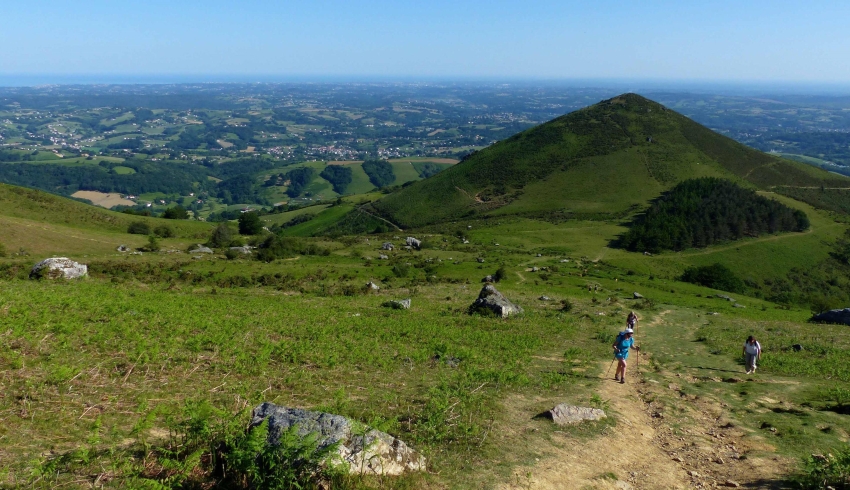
251, 402, 426, 475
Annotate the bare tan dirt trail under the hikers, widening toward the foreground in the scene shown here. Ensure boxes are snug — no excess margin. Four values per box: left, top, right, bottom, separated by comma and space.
497, 311, 785, 490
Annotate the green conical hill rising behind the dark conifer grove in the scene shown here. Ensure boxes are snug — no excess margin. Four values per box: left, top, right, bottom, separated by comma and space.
375, 94, 850, 227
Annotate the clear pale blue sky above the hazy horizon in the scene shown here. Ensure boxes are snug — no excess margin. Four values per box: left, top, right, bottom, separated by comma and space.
0, 0, 850, 84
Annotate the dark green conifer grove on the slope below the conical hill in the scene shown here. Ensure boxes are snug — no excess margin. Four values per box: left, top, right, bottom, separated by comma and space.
620, 178, 809, 253
